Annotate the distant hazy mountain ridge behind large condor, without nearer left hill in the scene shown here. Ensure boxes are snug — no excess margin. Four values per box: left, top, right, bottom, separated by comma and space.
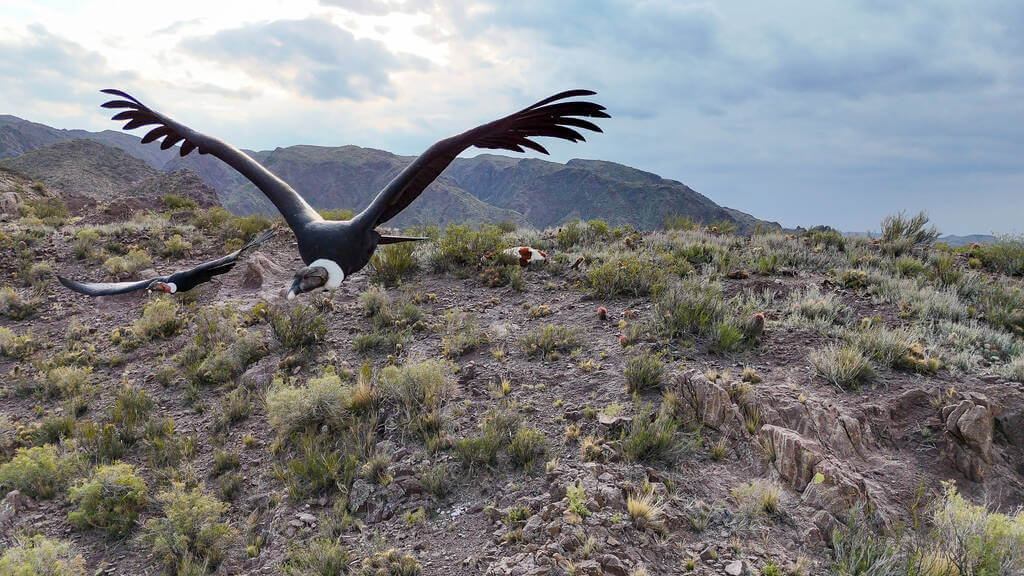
0, 116, 778, 234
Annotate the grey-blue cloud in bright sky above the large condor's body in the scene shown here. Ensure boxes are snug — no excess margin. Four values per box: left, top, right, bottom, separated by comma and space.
181, 17, 427, 100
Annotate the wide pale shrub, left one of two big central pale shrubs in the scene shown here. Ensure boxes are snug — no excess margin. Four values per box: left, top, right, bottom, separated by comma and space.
266, 366, 351, 438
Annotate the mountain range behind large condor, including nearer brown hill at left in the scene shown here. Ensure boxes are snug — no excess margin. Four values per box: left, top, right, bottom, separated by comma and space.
0, 116, 778, 233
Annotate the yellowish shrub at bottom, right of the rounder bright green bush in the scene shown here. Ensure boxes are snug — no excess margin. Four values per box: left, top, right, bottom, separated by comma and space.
143, 483, 237, 574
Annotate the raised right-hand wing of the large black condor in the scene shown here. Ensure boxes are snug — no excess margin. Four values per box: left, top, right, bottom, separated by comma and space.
355, 90, 610, 225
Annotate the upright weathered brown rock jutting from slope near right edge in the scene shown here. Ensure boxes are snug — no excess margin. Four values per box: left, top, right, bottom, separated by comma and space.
942, 394, 995, 482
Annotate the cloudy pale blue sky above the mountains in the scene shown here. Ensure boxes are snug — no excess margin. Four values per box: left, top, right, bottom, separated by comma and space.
0, 0, 1024, 235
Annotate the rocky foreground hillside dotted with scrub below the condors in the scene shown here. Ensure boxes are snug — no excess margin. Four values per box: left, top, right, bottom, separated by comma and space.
0, 190, 1024, 576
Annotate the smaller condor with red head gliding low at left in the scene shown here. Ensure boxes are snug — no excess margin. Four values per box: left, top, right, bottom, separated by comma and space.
57, 230, 275, 296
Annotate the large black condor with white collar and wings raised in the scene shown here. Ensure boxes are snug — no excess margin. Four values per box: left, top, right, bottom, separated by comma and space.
102, 89, 609, 298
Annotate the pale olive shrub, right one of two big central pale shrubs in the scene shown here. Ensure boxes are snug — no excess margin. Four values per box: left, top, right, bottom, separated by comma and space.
380, 360, 454, 440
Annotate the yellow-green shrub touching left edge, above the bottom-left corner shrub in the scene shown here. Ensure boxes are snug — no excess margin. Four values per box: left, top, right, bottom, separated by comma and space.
0, 444, 78, 499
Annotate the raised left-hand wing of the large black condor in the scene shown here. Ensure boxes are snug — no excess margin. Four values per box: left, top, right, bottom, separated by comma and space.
100, 88, 322, 231
